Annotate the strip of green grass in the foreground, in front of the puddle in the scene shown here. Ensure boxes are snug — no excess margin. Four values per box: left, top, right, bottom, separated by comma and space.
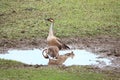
0, 59, 118, 80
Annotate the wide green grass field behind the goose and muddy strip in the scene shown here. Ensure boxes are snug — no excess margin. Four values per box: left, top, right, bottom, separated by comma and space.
0, 0, 120, 39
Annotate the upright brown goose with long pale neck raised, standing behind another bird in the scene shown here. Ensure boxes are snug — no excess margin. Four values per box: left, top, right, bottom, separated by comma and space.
46, 18, 70, 50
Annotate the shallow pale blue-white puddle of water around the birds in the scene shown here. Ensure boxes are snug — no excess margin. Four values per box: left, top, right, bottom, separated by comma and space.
0, 49, 111, 67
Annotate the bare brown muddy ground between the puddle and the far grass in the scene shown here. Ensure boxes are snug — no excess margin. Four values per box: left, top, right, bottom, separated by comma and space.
0, 36, 120, 72
